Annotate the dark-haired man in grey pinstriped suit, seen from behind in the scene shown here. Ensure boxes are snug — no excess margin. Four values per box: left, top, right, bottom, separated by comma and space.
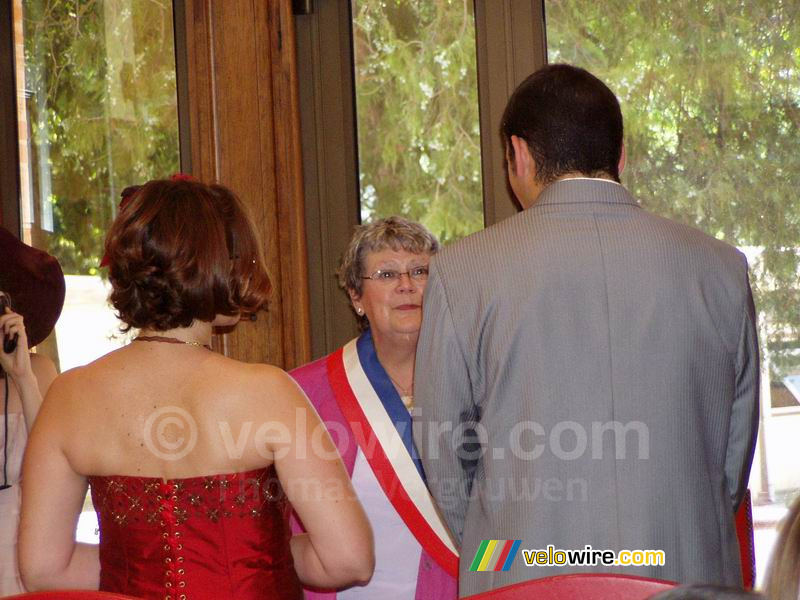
414, 65, 759, 597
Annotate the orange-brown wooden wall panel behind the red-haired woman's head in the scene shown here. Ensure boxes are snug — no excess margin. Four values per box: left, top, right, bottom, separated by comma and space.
185, 0, 310, 368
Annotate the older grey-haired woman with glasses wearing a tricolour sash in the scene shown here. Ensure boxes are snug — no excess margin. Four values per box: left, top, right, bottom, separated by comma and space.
290, 217, 458, 600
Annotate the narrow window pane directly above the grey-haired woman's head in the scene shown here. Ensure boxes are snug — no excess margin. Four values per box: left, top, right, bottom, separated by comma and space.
352, 0, 483, 241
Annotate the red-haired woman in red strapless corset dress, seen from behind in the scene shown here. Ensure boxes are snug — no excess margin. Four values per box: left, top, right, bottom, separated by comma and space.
19, 180, 373, 600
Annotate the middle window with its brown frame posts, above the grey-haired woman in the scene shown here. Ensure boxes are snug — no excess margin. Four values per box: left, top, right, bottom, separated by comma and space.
296, 0, 544, 358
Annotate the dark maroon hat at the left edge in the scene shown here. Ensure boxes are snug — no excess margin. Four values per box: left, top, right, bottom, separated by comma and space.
0, 227, 66, 348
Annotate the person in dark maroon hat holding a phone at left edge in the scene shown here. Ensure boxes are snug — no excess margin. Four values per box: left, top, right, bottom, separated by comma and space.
0, 227, 66, 596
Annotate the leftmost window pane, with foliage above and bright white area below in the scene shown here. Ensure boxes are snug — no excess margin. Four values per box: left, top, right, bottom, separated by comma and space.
13, 0, 180, 540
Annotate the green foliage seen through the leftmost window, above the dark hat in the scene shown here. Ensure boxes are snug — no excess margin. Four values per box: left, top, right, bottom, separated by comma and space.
24, 0, 179, 273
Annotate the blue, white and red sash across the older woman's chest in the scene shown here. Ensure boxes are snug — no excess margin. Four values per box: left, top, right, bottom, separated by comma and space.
328, 333, 458, 576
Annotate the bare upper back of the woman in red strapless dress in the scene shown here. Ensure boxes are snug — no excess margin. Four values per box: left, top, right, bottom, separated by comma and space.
53, 341, 282, 479
